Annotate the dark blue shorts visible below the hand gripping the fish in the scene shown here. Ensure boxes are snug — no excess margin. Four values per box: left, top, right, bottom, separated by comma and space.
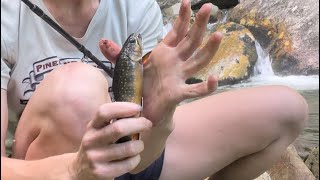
115, 151, 164, 180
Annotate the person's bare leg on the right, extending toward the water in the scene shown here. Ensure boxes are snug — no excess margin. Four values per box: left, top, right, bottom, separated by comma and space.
160, 86, 308, 180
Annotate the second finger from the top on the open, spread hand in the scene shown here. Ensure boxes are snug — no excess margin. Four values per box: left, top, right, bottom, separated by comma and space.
177, 3, 212, 60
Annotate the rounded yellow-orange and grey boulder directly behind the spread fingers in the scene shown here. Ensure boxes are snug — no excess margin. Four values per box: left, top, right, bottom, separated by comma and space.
193, 22, 257, 85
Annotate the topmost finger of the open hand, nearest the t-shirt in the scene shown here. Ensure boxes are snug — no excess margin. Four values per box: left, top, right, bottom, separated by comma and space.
162, 0, 191, 47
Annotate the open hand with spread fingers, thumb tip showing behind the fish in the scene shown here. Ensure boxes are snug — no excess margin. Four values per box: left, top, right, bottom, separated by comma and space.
100, 0, 222, 125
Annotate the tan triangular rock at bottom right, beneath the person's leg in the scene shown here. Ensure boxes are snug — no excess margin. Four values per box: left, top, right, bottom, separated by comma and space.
267, 145, 316, 180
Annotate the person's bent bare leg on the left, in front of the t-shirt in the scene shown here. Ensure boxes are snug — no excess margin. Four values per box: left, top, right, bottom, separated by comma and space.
14, 63, 110, 159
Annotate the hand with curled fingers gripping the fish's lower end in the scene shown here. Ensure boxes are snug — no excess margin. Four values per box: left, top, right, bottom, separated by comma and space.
72, 102, 152, 179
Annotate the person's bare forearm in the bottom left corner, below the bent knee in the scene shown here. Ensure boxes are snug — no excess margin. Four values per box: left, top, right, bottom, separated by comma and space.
1, 154, 74, 180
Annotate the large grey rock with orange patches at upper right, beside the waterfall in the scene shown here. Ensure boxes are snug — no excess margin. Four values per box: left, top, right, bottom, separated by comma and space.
230, 0, 319, 75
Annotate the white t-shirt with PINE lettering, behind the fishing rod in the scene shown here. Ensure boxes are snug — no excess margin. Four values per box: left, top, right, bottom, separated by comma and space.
1, 0, 163, 153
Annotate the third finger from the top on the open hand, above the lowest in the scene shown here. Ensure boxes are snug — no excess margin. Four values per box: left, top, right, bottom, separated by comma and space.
183, 32, 223, 78
